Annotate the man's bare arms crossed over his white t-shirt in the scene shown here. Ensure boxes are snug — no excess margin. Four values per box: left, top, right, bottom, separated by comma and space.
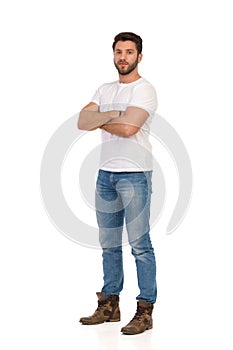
78, 102, 149, 137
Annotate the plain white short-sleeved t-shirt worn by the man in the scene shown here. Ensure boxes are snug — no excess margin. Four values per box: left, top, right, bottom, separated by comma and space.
92, 78, 157, 172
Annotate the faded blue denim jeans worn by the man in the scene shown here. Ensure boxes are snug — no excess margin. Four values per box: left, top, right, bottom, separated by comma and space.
96, 170, 157, 304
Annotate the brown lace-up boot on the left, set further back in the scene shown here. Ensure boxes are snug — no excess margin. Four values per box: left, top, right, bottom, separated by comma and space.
80, 292, 120, 325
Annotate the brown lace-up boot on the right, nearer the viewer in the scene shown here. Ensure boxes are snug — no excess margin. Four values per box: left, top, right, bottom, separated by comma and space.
121, 300, 154, 334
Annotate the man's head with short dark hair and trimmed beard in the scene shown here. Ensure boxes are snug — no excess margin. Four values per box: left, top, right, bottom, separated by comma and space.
112, 32, 142, 75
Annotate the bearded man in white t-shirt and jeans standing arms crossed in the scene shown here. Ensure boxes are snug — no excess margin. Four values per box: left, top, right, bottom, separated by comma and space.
78, 32, 157, 334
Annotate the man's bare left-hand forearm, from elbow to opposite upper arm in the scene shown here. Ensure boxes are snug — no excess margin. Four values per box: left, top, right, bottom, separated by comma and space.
78, 109, 119, 130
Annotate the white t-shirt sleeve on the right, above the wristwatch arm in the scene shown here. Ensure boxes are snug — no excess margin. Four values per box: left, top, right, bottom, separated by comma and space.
128, 82, 158, 116
